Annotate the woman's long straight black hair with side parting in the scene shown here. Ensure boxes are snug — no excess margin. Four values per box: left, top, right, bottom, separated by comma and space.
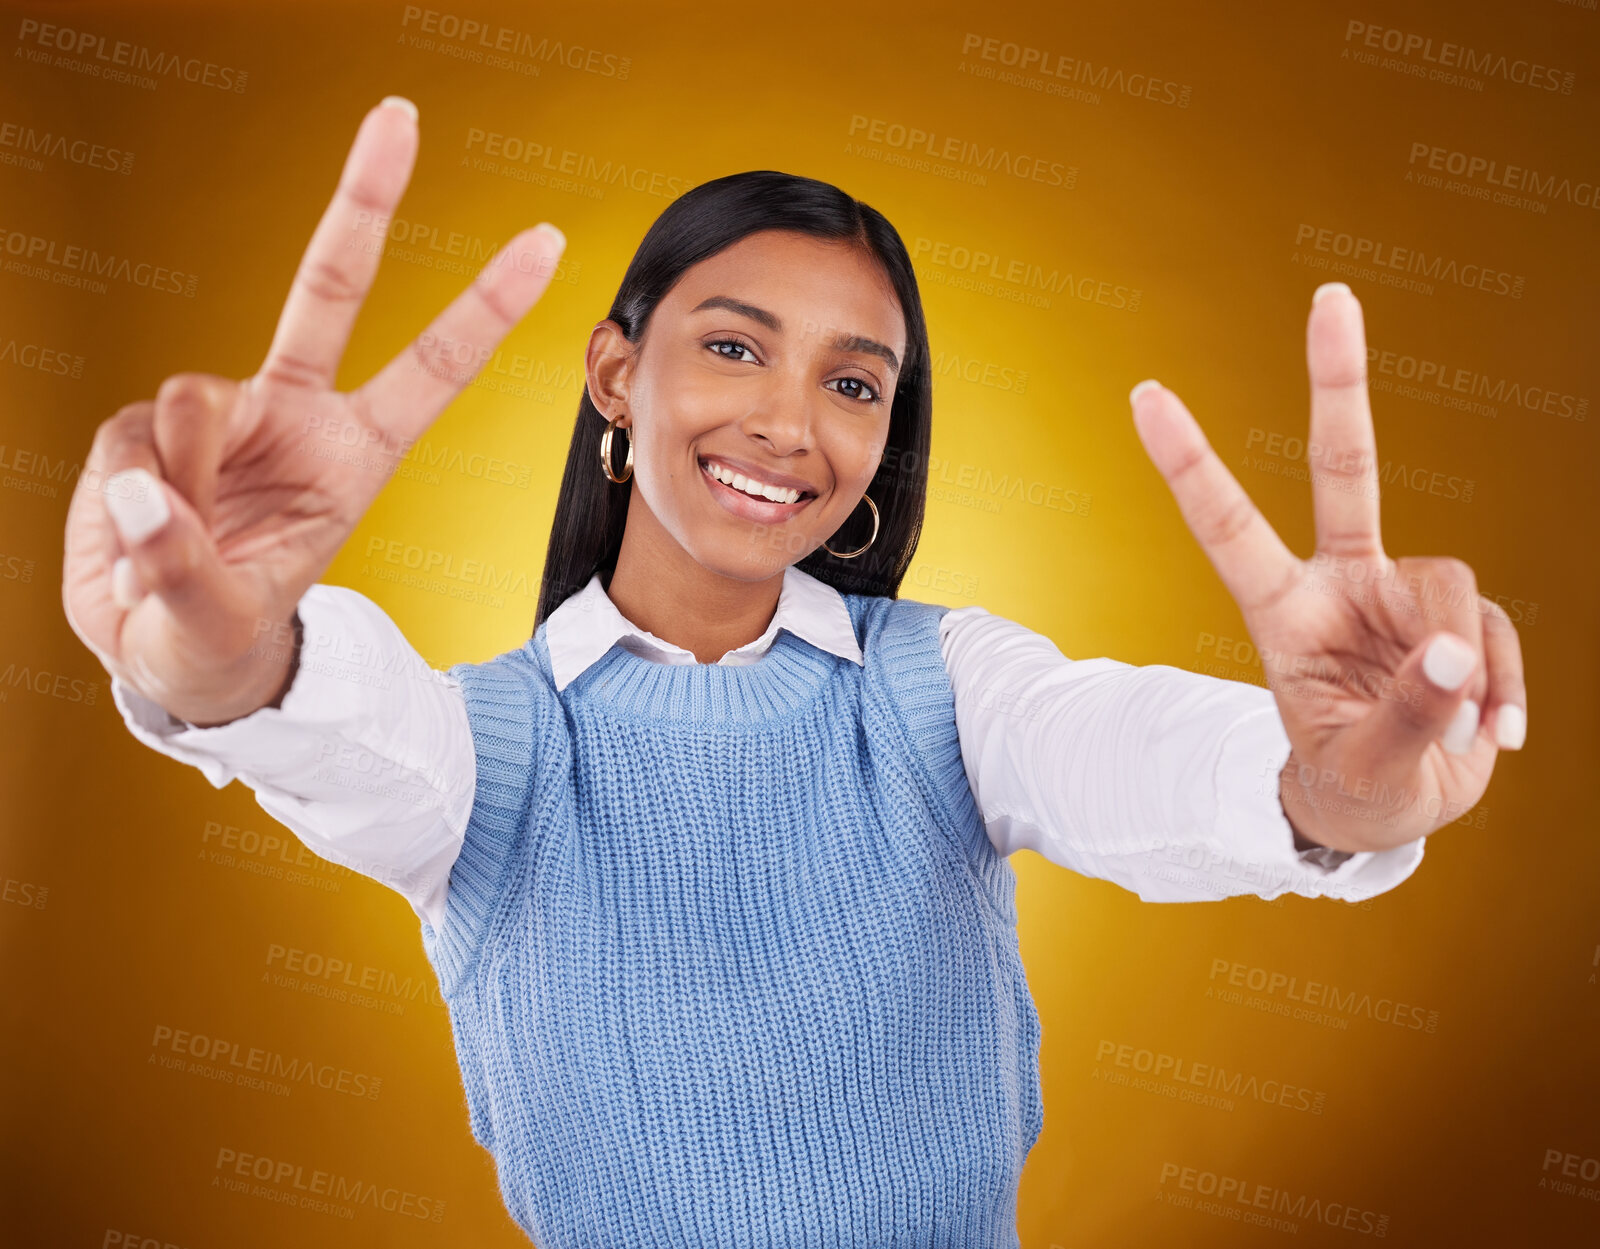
533, 170, 933, 632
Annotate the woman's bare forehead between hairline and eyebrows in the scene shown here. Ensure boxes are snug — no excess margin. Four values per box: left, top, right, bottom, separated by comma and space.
661, 230, 906, 360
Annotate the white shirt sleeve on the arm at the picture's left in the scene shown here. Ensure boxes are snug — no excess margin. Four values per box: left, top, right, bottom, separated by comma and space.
112, 584, 477, 928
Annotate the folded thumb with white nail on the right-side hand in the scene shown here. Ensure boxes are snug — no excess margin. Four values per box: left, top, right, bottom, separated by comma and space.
1331, 630, 1483, 779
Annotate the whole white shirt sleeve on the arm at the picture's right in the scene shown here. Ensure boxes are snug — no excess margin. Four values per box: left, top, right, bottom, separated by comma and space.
939, 606, 1426, 902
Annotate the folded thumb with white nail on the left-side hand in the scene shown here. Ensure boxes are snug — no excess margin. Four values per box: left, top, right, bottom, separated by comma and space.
104, 467, 243, 644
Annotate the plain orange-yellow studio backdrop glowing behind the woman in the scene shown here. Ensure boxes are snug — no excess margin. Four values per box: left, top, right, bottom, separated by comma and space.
0, 0, 1600, 1249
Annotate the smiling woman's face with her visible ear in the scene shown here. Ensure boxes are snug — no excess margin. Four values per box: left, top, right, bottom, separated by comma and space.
587, 230, 906, 581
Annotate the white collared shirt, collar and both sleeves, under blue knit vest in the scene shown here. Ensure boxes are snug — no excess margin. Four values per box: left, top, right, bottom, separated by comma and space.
112, 565, 1426, 928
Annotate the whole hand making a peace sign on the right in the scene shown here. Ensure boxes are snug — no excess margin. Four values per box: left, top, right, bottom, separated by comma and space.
1131, 283, 1528, 851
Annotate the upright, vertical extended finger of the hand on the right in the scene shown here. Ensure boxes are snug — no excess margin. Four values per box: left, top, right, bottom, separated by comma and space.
1306, 281, 1382, 555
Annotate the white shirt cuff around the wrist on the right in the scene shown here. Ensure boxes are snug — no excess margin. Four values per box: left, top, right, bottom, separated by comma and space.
1214, 702, 1427, 902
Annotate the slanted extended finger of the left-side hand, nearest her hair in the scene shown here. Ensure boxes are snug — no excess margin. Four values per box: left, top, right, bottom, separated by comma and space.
350, 222, 566, 443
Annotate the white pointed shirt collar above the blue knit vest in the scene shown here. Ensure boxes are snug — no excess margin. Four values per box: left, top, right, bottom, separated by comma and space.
544, 565, 862, 689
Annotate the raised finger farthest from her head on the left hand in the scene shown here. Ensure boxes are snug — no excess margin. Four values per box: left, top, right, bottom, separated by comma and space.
259, 96, 418, 389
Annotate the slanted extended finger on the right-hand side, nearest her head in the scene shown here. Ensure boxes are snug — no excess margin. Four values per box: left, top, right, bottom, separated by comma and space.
1131, 382, 1304, 613
